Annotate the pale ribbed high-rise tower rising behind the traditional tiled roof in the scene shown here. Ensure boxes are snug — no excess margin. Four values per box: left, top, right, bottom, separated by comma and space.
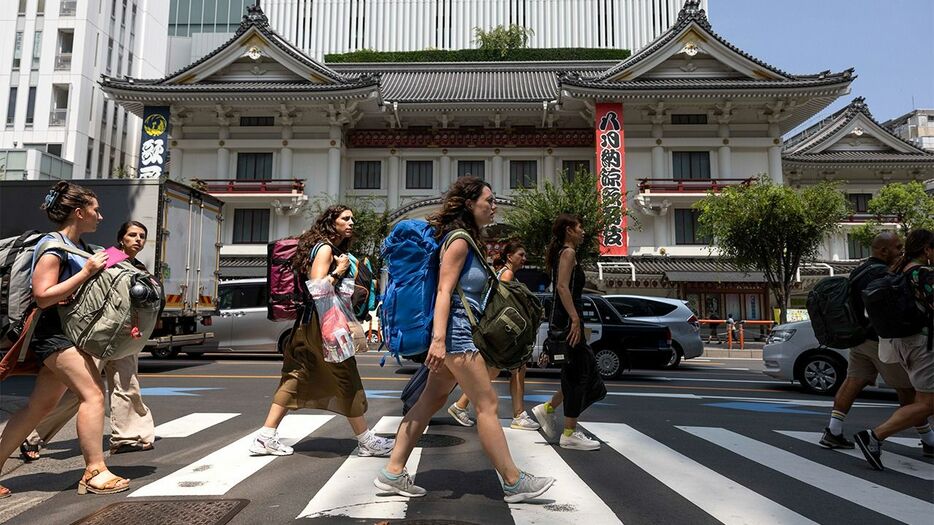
168, 0, 707, 71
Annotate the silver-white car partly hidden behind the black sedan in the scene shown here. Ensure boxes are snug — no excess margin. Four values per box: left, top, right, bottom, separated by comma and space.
603, 295, 704, 369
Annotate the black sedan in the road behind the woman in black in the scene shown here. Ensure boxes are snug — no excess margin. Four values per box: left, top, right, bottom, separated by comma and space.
529, 294, 671, 379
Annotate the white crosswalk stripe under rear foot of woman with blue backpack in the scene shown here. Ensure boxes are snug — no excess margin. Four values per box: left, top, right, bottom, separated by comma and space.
298, 416, 427, 519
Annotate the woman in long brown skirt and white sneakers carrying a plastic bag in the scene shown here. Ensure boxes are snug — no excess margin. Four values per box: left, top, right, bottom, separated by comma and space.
250, 204, 394, 456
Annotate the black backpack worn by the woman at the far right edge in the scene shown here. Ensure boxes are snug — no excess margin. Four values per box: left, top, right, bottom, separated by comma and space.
863, 273, 931, 338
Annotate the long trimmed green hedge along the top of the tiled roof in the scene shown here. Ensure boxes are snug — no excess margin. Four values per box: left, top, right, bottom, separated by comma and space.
324, 47, 630, 64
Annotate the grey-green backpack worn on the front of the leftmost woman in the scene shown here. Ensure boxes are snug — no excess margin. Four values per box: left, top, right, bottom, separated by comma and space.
36, 241, 162, 360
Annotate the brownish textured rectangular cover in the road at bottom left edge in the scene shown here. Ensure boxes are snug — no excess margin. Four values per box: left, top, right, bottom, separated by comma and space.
71, 499, 250, 525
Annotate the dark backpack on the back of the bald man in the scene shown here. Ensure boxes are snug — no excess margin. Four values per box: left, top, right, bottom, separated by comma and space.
807, 264, 881, 348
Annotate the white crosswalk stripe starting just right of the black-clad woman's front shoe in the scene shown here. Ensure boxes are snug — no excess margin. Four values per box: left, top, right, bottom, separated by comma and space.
583, 423, 814, 524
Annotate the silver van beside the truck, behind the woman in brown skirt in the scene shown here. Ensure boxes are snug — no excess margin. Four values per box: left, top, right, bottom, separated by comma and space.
177, 279, 292, 354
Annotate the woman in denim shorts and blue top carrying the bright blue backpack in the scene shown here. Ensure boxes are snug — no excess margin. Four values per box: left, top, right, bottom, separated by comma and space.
373, 176, 555, 503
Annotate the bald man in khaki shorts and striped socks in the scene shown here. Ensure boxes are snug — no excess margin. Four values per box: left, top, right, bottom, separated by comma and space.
819, 231, 934, 455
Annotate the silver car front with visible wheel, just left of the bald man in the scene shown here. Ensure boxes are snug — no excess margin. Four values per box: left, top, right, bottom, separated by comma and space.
762, 321, 849, 394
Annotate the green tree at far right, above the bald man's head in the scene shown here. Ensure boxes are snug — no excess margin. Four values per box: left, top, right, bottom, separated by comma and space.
850, 181, 934, 246
